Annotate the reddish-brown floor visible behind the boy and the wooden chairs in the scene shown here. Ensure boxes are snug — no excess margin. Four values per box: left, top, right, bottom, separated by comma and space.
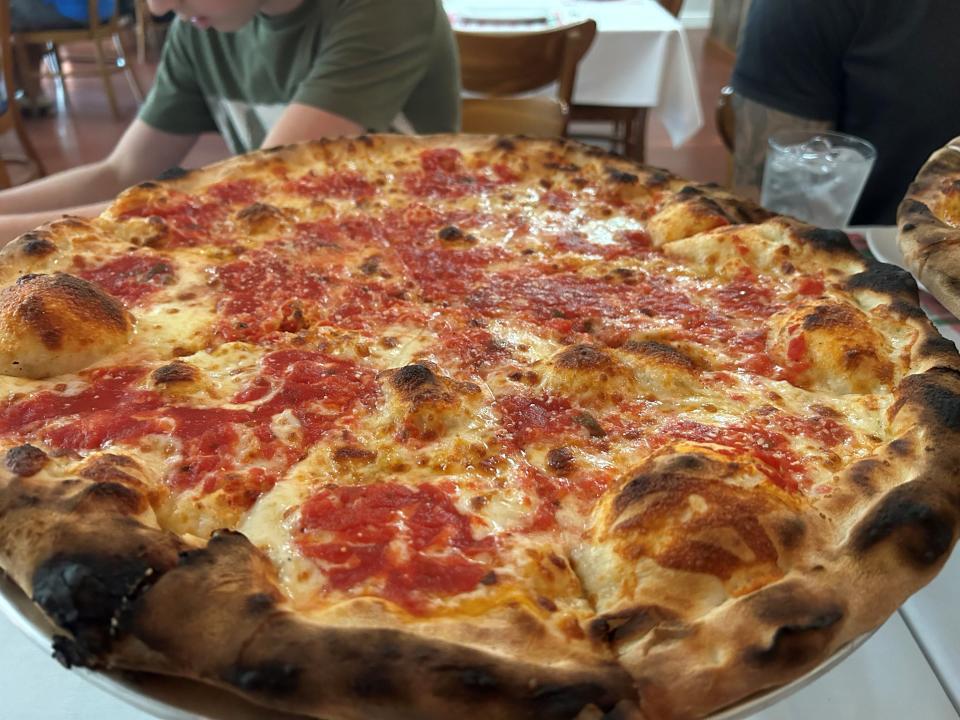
3, 30, 732, 184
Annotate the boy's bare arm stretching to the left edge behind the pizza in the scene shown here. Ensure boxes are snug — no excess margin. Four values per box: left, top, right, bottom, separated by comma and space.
0, 118, 197, 219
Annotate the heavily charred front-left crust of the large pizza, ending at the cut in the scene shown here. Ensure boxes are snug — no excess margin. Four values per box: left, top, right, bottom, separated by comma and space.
0, 458, 634, 720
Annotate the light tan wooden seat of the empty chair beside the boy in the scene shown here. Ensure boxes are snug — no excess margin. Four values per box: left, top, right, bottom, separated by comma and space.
461, 97, 568, 137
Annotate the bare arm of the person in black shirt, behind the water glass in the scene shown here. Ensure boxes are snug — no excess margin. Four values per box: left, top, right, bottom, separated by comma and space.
733, 94, 834, 199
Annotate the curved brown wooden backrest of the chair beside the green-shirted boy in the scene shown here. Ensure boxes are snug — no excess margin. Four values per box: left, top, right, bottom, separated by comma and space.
456, 20, 597, 103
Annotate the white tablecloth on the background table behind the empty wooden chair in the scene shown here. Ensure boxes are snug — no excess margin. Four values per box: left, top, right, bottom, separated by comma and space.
444, 0, 703, 147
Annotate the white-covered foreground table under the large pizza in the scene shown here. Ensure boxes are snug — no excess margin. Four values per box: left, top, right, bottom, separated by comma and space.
0, 228, 960, 720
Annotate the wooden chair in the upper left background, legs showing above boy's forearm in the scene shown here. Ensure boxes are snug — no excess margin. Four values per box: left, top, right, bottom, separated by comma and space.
14, 0, 143, 120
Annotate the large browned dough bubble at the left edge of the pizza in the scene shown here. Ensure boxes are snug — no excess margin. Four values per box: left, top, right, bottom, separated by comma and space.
0, 273, 133, 379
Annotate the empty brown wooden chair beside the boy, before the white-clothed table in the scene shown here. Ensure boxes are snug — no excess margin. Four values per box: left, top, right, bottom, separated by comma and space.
456, 20, 597, 137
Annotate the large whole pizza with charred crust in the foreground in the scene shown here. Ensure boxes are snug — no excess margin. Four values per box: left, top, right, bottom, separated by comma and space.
0, 136, 960, 720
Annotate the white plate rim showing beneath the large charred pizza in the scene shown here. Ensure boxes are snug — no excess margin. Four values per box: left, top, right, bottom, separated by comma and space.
0, 572, 872, 720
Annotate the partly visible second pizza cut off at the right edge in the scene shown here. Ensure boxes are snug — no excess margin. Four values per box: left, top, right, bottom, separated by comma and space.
897, 138, 960, 316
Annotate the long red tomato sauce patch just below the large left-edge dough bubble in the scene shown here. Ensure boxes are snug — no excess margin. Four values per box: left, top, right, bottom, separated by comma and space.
0, 350, 377, 507
